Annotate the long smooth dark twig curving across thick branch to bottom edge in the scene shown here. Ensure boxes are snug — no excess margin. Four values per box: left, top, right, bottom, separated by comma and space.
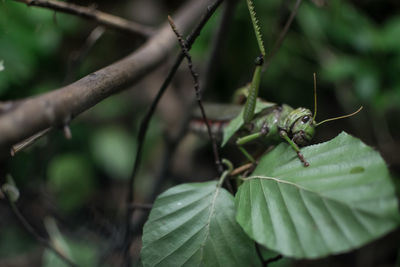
122, 0, 223, 266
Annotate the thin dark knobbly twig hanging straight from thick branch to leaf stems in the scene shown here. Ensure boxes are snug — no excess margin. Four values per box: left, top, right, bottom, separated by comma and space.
168, 16, 224, 174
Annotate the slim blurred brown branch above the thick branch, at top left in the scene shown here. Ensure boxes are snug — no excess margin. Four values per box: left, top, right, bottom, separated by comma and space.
14, 0, 155, 37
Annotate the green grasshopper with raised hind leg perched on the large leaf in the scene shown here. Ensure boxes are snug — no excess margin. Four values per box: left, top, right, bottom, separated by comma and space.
222, 57, 362, 167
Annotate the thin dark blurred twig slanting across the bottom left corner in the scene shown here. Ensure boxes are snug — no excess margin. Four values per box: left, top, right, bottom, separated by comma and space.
0, 188, 78, 267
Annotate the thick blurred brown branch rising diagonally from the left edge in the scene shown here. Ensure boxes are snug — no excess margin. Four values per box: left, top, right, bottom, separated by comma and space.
0, 0, 209, 158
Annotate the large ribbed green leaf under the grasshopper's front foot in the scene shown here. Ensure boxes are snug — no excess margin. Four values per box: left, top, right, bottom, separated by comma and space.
236, 133, 399, 258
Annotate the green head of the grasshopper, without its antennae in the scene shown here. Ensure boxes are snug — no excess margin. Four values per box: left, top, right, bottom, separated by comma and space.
286, 108, 316, 146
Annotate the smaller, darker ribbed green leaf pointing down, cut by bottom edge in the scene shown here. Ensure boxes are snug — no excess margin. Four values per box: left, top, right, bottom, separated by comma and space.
141, 181, 260, 267
